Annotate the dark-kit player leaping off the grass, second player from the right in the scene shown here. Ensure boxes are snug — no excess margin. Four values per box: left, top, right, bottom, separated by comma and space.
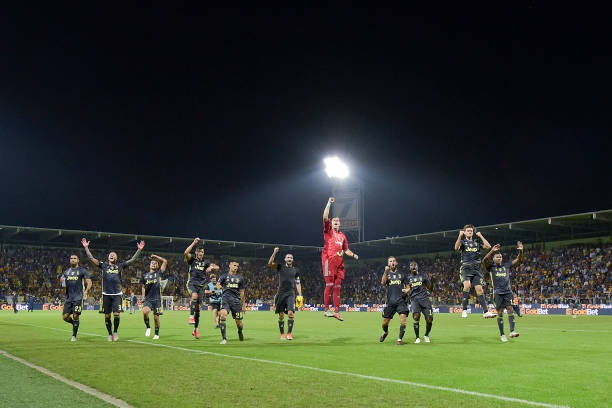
455, 224, 495, 319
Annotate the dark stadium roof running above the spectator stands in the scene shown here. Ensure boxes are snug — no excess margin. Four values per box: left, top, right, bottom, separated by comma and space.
0, 210, 612, 259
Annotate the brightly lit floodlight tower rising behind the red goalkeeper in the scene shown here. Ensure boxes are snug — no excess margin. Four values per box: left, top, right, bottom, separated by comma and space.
324, 156, 364, 242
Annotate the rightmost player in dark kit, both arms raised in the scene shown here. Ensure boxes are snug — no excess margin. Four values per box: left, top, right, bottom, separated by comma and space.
482, 241, 523, 343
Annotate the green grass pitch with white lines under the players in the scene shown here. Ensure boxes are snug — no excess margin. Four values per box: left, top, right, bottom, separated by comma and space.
0, 311, 612, 408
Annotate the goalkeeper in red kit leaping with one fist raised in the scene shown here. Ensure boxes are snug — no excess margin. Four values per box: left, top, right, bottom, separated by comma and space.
322, 197, 359, 321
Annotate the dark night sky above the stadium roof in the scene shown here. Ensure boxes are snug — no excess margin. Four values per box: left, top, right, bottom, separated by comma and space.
0, 6, 612, 245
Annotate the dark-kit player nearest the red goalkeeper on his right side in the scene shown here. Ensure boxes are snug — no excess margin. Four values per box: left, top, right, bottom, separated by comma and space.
379, 256, 408, 346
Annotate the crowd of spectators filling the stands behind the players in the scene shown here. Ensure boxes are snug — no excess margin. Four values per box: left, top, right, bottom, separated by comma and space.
0, 244, 612, 305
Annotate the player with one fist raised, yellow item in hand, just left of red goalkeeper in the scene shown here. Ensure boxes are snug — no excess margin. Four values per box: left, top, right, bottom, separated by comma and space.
268, 247, 304, 340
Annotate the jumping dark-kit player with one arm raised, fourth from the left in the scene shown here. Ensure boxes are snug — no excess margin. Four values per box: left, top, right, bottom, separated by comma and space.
185, 238, 219, 339
